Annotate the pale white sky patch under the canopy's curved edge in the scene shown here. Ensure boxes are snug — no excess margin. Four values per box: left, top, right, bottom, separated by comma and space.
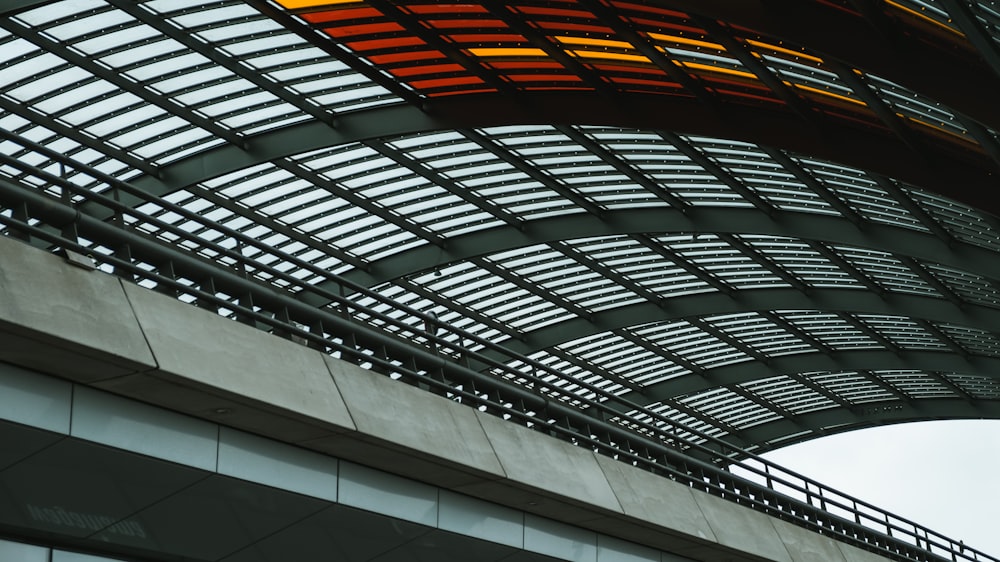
762, 420, 1000, 558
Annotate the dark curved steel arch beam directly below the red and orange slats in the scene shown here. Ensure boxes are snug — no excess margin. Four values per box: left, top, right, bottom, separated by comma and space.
74, 93, 1000, 218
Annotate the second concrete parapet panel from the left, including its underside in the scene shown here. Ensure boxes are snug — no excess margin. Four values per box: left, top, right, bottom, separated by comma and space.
97, 283, 355, 443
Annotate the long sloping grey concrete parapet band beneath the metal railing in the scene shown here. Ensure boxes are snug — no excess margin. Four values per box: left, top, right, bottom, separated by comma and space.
0, 233, 882, 562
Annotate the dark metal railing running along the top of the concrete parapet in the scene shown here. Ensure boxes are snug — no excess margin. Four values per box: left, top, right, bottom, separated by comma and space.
0, 154, 998, 562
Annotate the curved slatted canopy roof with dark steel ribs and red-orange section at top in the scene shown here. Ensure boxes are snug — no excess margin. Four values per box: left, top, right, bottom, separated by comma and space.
0, 0, 1000, 460
